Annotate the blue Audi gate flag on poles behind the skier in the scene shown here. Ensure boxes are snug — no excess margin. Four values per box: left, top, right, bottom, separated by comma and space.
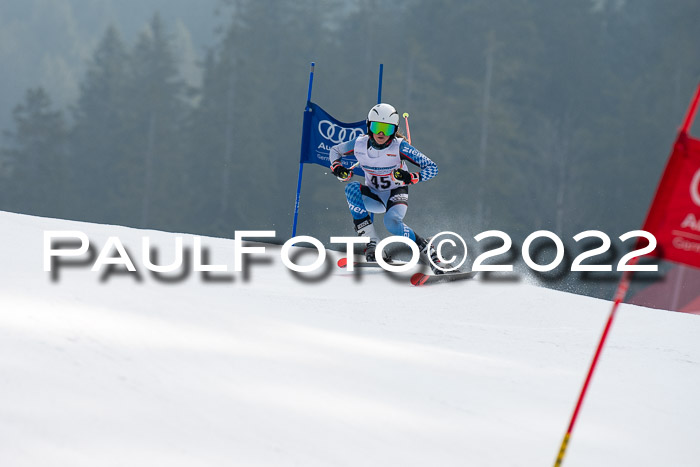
299, 102, 367, 177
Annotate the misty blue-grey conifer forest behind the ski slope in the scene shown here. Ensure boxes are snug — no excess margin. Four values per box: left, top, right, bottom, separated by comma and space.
0, 0, 700, 298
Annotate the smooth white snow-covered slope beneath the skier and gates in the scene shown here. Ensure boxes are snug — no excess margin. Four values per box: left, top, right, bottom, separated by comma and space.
0, 213, 700, 467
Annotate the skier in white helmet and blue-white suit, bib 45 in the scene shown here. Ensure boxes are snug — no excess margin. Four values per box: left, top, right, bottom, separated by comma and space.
330, 104, 443, 274
